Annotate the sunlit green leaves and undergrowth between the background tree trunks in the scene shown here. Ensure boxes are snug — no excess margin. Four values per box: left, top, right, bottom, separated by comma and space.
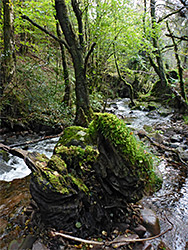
0, 0, 187, 129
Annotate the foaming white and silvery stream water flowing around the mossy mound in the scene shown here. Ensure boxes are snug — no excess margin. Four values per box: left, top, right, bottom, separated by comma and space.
0, 99, 188, 250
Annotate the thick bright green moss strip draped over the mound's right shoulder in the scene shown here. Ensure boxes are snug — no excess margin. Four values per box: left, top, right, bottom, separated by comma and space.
89, 113, 157, 188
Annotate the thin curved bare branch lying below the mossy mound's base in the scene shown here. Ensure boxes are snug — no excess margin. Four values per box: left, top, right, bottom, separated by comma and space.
50, 215, 173, 247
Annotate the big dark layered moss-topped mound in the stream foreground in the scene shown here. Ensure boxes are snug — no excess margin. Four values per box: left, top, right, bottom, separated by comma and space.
30, 114, 162, 237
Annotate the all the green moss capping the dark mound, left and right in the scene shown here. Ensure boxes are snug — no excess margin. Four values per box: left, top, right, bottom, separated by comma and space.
32, 114, 161, 197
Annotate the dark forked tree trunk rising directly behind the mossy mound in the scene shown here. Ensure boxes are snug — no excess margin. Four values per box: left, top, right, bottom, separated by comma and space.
55, 0, 92, 126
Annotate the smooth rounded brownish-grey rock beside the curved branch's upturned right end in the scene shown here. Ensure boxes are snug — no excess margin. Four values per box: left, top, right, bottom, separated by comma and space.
140, 208, 160, 236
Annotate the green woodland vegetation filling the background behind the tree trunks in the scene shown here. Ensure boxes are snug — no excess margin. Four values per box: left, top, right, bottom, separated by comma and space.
0, 0, 188, 127
